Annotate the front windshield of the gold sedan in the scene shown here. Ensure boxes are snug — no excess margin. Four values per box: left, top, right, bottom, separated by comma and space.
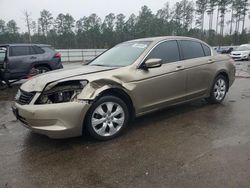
89, 42, 151, 67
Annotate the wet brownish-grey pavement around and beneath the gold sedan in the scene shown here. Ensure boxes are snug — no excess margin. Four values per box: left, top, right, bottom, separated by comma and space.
0, 65, 250, 188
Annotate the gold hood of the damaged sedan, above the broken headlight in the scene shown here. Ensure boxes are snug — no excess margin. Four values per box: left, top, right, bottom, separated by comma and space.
21, 65, 115, 92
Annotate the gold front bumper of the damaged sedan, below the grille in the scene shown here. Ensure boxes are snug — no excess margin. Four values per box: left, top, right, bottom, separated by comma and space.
12, 101, 90, 138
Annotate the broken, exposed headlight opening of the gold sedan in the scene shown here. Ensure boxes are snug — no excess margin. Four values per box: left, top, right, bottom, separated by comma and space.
36, 80, 88, 104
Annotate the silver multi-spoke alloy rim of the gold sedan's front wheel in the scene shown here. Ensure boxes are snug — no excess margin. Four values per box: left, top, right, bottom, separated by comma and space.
91, 102, 125, 136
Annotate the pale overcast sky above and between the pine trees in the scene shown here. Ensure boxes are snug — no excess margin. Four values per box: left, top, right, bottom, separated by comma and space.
0, 0, 250, 32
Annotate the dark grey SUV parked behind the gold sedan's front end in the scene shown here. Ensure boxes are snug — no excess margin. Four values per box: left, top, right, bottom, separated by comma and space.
0, 44, 63, 80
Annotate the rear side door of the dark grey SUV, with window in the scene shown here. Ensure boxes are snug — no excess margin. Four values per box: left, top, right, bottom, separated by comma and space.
8, 45, 36, 79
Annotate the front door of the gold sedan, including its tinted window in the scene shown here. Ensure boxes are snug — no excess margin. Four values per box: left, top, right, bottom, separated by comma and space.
134, 40, 187, 113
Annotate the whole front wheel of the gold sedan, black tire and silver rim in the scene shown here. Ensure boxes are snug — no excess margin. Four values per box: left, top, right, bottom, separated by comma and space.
86, 96, 129, 141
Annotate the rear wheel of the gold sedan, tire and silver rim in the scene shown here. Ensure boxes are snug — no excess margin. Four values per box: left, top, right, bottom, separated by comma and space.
206, 75, 228, 104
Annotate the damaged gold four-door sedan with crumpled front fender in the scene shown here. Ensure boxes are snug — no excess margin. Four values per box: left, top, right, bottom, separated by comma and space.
13, 36, 235, 140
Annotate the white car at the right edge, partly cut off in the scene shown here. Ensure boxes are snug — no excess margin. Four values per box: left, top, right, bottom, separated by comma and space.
230, 44, 250, 60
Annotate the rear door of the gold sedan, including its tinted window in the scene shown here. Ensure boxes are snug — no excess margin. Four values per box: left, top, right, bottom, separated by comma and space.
178, 40, 214, 99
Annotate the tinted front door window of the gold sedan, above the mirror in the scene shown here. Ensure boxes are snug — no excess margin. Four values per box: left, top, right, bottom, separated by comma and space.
147, 40, 180, 63
